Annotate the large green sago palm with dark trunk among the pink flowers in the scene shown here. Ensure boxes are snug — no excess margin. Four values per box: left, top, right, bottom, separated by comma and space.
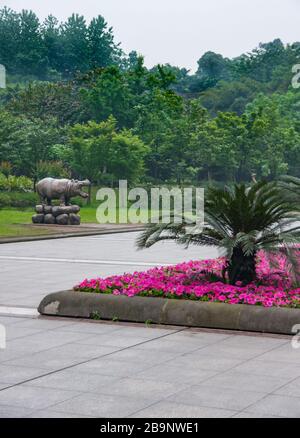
137, 181, 300, 285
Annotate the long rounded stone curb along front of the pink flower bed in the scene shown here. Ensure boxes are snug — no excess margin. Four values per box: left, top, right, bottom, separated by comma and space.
38, 290, 300, 334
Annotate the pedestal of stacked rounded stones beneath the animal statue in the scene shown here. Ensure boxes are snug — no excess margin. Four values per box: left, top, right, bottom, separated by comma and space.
32, 205, 80, 225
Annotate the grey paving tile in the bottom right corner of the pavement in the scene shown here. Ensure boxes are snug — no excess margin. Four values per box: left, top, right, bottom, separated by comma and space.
246, 394, 300, 418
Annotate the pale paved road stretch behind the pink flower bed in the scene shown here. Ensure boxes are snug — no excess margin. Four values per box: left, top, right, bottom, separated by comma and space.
0, 232, 217, 307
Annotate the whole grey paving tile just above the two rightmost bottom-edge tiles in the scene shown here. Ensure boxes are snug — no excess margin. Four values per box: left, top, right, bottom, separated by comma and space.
168, 382, 265, 411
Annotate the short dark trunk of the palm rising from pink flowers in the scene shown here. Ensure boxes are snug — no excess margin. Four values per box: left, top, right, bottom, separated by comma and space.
226, 247, 256, 286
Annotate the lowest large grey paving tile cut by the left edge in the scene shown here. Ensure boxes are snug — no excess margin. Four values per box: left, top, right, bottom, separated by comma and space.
0, 385, 79, 409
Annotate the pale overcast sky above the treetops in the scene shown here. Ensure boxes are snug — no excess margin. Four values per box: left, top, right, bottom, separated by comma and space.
0, 0, 300, 70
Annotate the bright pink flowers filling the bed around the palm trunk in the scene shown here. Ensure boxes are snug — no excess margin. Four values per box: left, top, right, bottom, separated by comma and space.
74, 252, 300, 308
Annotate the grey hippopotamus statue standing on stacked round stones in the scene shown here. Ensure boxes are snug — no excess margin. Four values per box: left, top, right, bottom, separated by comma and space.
36, 178, 91, 205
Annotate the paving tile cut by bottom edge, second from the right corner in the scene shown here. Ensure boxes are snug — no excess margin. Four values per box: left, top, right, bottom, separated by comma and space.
131, 401, 236, 418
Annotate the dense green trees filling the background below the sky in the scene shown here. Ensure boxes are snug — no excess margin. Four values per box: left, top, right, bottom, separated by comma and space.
0, 8, 300, 184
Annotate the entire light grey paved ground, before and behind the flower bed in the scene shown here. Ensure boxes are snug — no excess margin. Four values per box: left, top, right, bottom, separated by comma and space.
0, 234, 300, 418
